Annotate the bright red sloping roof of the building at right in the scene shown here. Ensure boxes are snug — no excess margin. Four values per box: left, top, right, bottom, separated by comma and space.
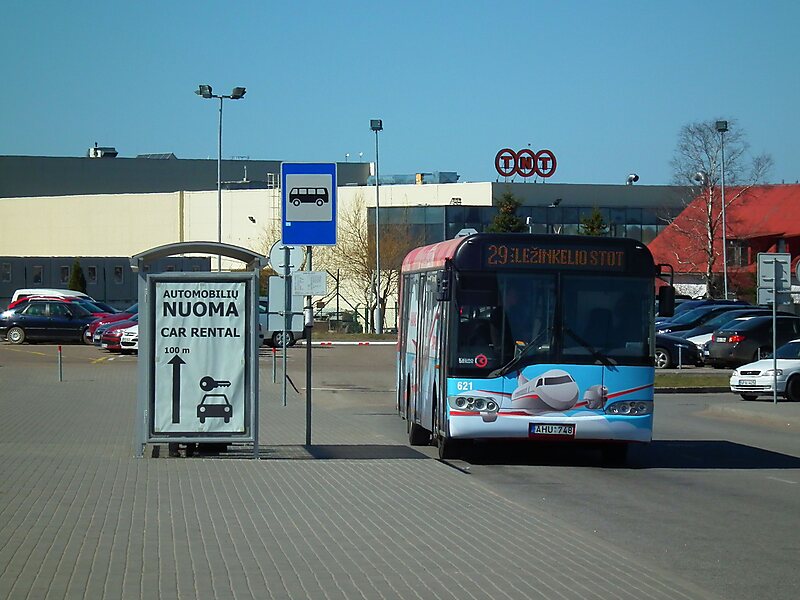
648, 184, 800, 273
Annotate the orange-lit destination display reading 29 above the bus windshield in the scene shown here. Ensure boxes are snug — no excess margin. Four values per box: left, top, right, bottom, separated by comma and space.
483, 243, 625, 271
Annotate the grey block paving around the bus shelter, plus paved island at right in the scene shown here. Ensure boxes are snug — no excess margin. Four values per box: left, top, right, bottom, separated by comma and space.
0, 344, 800, 600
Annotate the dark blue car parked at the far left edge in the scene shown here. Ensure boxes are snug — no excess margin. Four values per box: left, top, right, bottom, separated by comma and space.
0, 300, 95, 344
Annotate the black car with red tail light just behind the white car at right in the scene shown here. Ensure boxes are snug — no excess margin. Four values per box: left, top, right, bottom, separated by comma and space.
706, 316, 800, 368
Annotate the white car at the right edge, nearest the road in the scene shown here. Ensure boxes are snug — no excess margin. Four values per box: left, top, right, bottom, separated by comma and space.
731, 340, 800, 402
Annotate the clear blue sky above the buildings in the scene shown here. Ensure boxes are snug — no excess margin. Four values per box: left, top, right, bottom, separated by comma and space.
0, 0, 800, 185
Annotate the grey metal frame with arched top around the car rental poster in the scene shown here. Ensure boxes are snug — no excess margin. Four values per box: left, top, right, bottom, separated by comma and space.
130, 242, 268, 458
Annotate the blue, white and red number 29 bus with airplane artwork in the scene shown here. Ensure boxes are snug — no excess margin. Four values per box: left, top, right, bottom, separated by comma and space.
397, 233, 674, 462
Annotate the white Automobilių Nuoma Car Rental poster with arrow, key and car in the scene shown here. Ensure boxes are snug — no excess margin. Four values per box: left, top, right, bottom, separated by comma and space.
151, 280, 252, 435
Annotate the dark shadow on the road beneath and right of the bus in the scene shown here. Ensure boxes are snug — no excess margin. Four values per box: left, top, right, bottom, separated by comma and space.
463, 440, 800, 469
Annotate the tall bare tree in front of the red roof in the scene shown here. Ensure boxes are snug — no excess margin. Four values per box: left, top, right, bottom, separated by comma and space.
670, 119, 772, 296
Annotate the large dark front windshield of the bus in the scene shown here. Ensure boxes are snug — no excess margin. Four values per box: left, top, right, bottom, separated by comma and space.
449, 271, 653, 377
